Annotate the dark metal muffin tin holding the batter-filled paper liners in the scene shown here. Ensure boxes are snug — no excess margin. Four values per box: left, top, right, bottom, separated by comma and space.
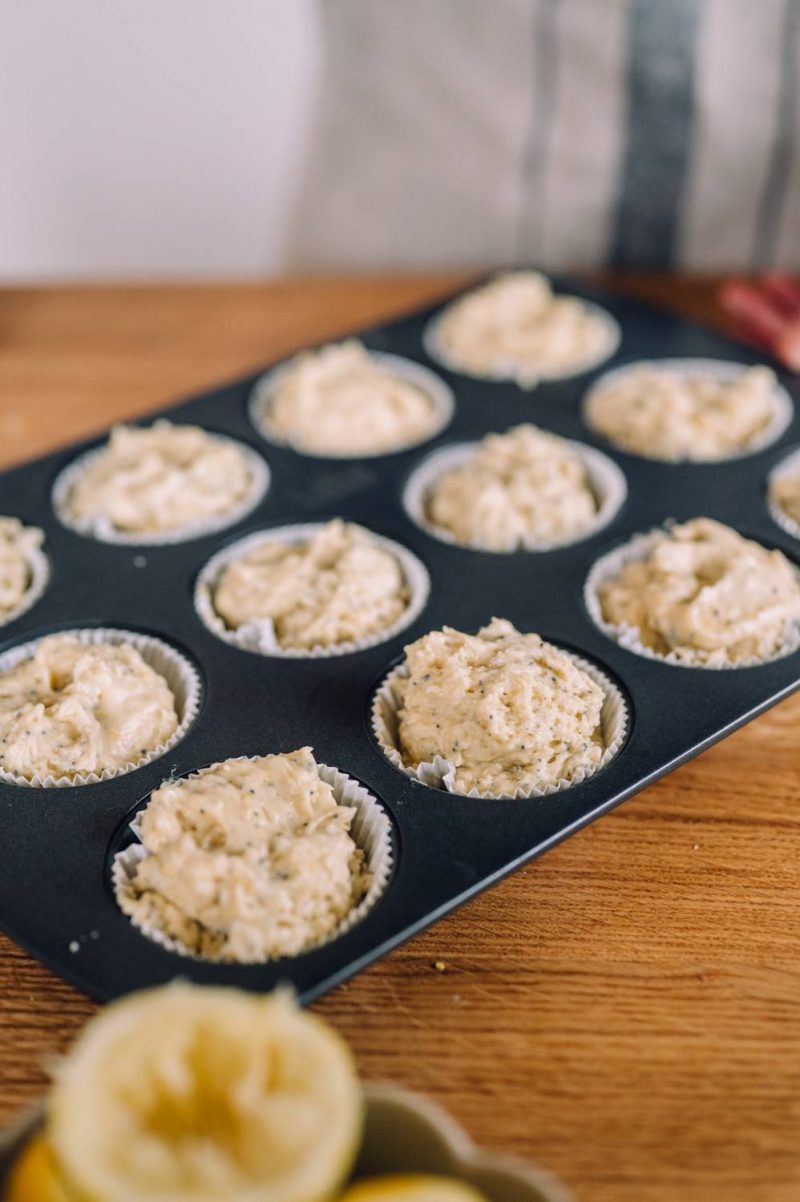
0, 281, 800, 1001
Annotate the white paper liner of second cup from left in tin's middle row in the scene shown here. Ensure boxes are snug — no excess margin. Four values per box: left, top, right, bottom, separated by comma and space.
195, 522, 430, 660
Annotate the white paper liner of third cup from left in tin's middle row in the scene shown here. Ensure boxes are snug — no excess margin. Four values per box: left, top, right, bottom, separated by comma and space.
402, 439, 628, 555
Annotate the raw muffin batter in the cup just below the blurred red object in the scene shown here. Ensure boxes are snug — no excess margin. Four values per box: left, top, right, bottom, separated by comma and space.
585, 363, 776, 463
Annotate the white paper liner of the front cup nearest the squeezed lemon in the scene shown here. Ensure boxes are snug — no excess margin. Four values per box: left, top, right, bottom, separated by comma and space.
112, 756, 394, 964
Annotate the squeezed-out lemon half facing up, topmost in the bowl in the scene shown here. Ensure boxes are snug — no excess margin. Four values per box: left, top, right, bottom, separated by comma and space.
40, 983, 363, 1202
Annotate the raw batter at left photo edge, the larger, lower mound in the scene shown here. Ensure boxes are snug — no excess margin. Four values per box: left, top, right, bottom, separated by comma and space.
0, 635, 178, 779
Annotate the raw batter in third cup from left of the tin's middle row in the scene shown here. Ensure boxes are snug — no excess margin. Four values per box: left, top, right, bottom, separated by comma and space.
428, 426, 597, 551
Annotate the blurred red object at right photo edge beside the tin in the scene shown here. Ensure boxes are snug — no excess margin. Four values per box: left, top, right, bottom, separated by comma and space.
720, 272, 800, 371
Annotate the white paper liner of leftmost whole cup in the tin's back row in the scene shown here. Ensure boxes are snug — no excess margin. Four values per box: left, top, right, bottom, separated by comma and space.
52, 430, 270, 547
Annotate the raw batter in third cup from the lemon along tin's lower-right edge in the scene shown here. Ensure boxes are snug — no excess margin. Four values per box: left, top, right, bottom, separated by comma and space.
598, 518, 800, 665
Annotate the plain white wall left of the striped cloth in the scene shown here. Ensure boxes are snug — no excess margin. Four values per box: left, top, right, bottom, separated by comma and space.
0, 0, 320, 280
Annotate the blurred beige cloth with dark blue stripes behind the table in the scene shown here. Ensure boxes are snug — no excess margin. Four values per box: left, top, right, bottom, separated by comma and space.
287, 0, 800, 269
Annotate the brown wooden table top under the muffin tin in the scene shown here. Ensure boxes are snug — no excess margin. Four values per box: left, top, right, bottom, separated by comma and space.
0, 276, 800, 1202
